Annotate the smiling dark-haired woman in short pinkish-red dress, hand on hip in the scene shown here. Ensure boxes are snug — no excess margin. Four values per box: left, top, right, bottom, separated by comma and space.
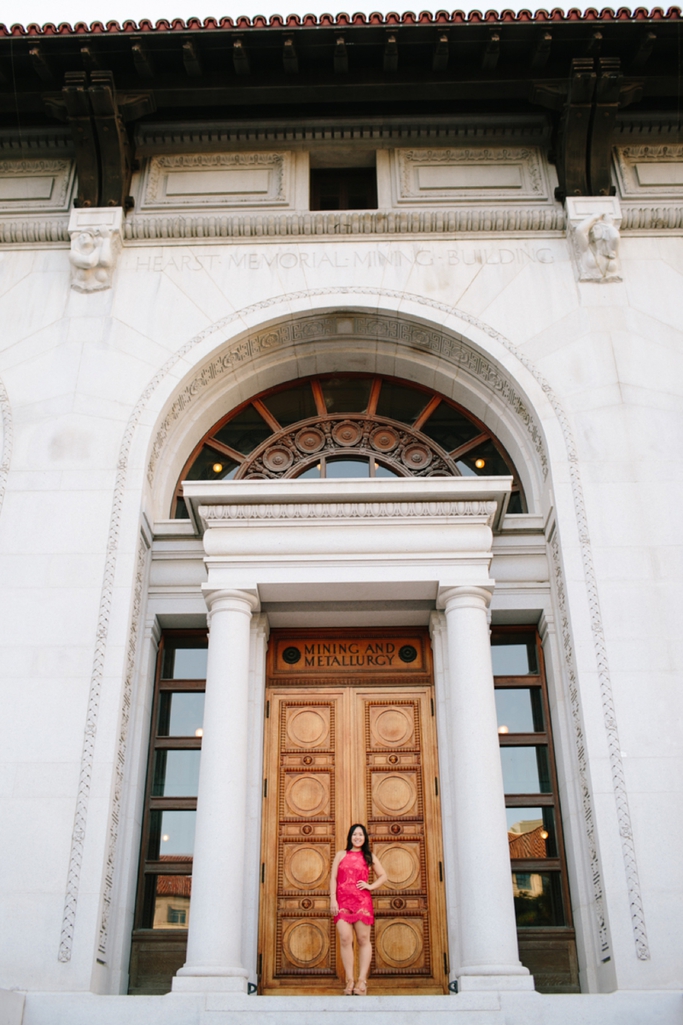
329, 823, 387, 996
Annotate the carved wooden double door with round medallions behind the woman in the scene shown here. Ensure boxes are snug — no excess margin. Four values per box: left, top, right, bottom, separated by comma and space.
258, 631, 448, 994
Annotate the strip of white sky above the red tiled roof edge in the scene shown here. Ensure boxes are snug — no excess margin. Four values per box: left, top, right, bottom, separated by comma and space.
0, 0, 639, 26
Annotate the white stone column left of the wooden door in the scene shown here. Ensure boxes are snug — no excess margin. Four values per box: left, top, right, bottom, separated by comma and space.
173, 589, 258, 992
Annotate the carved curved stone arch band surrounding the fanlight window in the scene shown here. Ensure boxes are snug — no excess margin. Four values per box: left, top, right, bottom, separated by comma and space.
147, 308, 549, 519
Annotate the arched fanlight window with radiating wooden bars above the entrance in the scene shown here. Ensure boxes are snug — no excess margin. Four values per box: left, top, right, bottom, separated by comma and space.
171, 374, 526, 519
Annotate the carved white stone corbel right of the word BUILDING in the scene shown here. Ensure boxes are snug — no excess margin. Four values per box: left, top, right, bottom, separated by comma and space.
566, 196, 621, 283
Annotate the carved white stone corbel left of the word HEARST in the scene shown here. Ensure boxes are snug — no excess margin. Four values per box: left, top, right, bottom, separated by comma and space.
69, 206, 123, 292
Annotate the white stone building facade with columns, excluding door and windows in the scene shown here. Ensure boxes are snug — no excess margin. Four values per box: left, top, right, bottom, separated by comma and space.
0, 46, 683, 1025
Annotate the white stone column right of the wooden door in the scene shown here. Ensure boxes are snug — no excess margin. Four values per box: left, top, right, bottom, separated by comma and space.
440, 585, 533, 990
